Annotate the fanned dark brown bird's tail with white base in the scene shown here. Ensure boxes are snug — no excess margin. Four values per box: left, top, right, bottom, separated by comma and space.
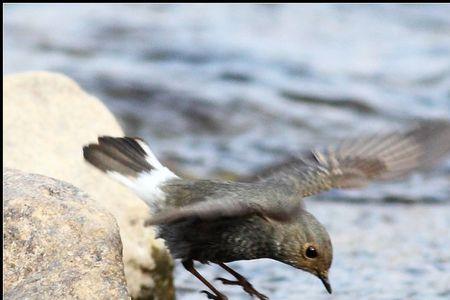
83, 136, 178, 206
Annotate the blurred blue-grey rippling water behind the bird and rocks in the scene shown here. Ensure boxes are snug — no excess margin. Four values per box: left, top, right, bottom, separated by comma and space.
3, 4, 450, 299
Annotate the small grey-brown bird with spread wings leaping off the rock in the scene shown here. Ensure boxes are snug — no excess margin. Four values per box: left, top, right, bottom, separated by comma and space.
83, 121, 450, 300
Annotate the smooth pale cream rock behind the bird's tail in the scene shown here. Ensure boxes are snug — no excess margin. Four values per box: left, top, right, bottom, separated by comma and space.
3, 72, 174, 299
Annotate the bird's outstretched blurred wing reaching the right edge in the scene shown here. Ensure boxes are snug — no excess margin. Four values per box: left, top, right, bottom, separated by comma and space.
251, 121, 450, 197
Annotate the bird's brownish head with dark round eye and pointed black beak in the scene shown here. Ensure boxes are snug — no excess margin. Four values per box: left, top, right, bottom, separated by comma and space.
272, 211, 333, 294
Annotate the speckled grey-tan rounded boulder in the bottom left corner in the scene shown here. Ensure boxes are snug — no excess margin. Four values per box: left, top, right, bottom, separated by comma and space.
3, 169, 130, 299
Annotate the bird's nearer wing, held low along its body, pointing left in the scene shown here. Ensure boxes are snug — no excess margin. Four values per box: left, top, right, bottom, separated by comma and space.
146, 183, 303, 225
